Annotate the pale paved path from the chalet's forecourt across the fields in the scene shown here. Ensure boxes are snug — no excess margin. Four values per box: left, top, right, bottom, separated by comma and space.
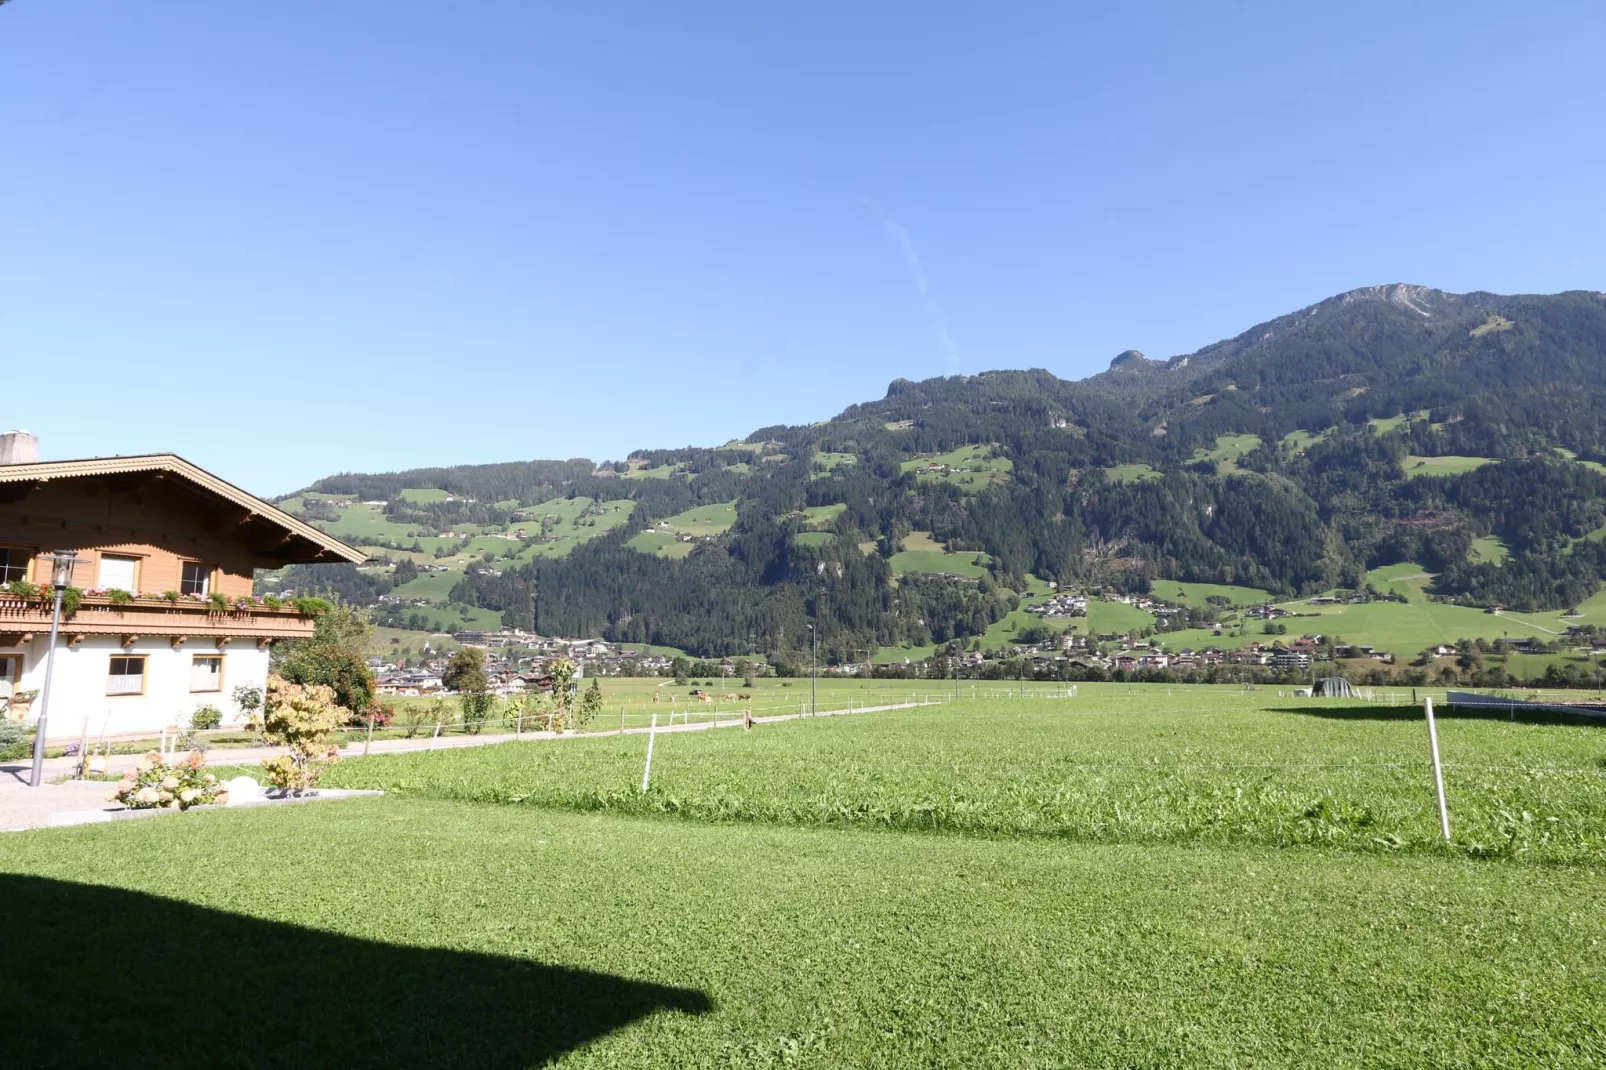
0, 702, 935, 831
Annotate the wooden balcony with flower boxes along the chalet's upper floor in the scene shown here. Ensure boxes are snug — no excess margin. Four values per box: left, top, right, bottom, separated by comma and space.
0, 594, 313, 646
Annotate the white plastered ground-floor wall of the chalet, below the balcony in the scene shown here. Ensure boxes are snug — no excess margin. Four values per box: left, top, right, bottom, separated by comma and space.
10, 635, 268, 741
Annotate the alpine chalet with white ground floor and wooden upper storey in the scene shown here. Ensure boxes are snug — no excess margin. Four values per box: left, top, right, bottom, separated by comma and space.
0, 432, 365, 739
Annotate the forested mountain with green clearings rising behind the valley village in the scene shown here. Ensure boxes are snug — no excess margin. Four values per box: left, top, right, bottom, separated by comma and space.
284, 284, 1606, 659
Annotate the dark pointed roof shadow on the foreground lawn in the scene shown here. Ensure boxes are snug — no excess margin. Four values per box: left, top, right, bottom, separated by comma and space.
0, 874, 713, 1068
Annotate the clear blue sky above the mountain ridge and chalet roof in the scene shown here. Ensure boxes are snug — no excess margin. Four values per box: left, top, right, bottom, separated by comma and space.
0, 0, 1606, 495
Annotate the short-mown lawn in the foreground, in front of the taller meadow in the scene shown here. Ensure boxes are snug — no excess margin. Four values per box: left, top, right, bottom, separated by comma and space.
0, 798, 1606, 1070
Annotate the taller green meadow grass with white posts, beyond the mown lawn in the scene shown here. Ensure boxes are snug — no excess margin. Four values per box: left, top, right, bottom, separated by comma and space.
309, 688, 1606, 863
